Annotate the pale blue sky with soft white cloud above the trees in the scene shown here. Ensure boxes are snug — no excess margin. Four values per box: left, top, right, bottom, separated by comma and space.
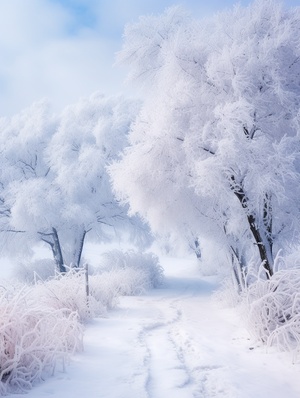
0, 0, 300, 116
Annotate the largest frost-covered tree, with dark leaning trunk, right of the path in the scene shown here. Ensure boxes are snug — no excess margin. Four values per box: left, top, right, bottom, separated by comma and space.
110, 0, 300, 277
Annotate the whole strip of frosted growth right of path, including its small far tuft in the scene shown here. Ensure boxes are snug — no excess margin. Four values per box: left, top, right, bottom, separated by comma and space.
214, 259, 300, 362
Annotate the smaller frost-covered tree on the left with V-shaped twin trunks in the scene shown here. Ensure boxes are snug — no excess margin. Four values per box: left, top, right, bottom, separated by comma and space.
0, 94, 145, 271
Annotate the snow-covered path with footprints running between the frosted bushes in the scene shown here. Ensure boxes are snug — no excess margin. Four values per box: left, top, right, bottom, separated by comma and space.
13, 260, 300, 398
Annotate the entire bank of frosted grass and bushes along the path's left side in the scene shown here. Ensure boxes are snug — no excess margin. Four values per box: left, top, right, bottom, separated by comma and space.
0, 251, 163, 395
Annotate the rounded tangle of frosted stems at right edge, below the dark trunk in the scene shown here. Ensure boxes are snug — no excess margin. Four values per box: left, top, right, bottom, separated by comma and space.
242, 269, 300, 359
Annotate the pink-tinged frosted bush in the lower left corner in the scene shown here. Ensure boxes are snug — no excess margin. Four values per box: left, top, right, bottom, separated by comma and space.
0, 286, 82, 395
